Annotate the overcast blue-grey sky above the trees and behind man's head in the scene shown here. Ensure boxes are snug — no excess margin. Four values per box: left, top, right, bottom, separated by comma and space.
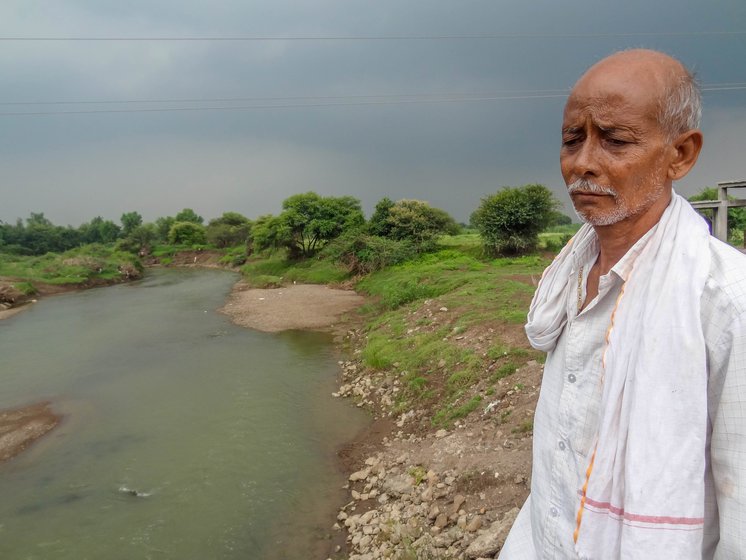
0, 0, 746, 226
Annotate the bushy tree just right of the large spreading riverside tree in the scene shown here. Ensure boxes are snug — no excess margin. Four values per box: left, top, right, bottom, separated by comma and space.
374, 200, 459, 245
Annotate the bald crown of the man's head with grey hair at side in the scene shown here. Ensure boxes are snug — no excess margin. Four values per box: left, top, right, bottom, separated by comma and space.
570, 49, 702, 140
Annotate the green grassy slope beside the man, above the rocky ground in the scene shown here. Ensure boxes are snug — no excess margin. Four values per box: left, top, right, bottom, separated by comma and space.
357, 244, 549, 426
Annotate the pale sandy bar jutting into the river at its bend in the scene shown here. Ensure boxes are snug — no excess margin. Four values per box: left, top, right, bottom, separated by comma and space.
220, 282, 365, 332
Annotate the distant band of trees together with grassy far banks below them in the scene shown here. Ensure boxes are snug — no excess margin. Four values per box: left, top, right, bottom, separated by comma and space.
0, 185, 572, 296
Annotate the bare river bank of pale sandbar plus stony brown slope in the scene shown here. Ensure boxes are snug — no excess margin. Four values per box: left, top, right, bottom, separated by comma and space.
221, 276, 542, 560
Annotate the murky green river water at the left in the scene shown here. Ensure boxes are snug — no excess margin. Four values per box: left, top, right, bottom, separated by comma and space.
0, 270, 366, 560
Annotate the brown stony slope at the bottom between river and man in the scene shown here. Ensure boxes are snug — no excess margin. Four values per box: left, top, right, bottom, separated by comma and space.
331, 301, 542, 560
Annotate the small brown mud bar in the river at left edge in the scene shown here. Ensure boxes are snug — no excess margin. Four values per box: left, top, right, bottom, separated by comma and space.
0, 402, 60, 462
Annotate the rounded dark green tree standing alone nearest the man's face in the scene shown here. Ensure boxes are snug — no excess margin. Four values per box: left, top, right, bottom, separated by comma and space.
471, 185, 559, 256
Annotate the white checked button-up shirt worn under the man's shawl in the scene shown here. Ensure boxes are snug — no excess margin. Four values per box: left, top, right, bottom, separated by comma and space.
500, 238, 746, 560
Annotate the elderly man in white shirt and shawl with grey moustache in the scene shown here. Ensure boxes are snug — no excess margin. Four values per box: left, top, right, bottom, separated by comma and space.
500, 50, 746, 560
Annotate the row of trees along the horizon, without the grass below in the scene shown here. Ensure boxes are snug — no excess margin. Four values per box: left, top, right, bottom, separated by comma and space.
0, 185, 571, 262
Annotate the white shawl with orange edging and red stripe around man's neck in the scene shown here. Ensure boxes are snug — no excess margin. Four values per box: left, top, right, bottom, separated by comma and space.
526, 193, 710, 560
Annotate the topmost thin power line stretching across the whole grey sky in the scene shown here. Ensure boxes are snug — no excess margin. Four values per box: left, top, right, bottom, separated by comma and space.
0, 30, 746, 42
